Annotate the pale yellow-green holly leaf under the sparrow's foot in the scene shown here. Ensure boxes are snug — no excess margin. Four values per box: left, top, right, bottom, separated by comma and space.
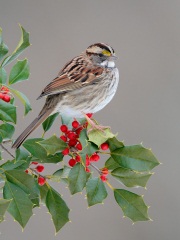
87, 125, 115, 147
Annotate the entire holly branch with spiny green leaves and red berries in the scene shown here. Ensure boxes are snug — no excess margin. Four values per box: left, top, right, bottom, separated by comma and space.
0, 26, 159, 232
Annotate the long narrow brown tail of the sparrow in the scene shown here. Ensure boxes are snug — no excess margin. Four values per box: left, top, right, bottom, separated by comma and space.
12, 111, 52, 148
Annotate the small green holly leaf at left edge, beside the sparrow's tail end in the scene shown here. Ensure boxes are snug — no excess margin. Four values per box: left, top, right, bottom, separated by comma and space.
0, 123, 15, 142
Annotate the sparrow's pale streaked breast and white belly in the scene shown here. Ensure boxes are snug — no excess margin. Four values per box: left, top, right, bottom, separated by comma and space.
54, 68, 119, 118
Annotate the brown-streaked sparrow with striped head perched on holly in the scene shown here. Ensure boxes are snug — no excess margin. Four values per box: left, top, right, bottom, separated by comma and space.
12, 43, 119, 148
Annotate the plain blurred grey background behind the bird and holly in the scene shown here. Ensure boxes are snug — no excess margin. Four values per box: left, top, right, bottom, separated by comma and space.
0, 0, 180, 240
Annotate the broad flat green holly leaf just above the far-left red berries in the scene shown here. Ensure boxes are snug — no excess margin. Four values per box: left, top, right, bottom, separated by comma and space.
9, 59, 29, 85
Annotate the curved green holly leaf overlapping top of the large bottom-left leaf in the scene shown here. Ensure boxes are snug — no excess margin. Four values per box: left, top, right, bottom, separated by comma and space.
5, 170, 39, 206
